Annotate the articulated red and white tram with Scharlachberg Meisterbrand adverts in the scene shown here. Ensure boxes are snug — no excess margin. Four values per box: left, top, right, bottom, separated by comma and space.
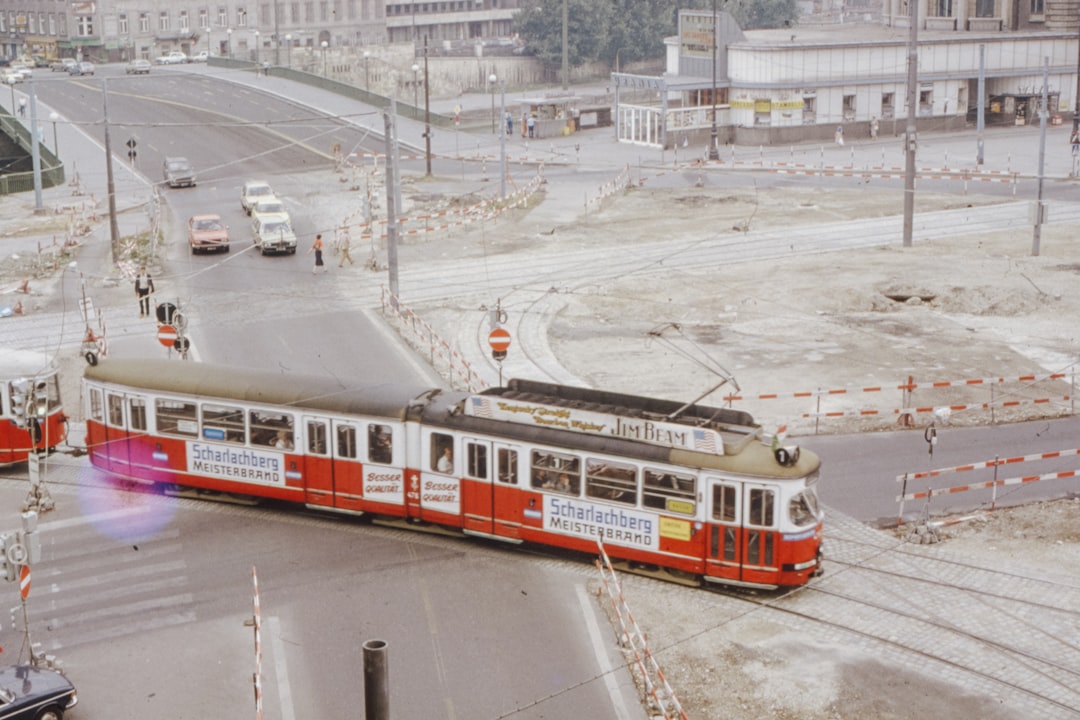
83, 358, 823, 587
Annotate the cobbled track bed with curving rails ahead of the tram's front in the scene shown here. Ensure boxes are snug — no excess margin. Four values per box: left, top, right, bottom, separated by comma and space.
745, 541, 1080, 718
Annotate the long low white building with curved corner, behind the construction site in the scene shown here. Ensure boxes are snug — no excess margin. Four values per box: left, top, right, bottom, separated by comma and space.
612, 8, 1080, 147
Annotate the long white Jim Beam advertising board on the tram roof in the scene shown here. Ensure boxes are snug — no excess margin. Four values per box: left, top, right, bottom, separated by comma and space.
465, 395, 724, 454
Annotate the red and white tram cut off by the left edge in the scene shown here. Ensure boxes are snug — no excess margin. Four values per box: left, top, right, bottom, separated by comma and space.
0, 348, 67, 465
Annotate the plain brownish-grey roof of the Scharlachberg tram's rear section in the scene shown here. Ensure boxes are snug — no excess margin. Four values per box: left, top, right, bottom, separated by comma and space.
83, 357, 432, 420
